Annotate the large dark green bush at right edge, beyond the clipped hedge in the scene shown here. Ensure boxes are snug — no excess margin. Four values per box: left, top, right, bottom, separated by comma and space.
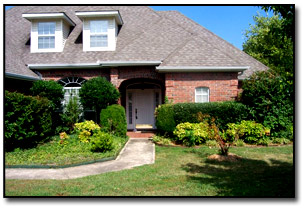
241, 71, 294, 139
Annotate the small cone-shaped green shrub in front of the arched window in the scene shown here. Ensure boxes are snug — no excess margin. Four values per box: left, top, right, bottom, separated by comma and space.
61, 96, 82, 132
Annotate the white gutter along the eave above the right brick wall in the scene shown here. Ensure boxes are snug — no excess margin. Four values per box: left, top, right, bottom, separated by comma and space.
156, 66, 249, 73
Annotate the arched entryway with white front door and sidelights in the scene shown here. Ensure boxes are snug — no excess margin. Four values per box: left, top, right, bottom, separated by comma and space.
119, 78, 164, 130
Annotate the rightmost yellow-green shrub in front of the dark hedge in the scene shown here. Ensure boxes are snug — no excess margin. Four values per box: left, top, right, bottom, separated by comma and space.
226, 120, 270, 144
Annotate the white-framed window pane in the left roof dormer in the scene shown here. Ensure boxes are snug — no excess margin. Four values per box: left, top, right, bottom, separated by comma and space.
38, 22, 56, 49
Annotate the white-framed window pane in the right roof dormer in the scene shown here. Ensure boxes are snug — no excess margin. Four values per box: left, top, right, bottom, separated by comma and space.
90, 20, 108, 48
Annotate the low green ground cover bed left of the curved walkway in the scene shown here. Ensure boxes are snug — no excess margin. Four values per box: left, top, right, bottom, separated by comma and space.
5, 134, 126, 166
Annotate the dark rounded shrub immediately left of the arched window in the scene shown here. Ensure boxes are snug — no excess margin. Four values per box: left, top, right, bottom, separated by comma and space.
31, 80, 64, 110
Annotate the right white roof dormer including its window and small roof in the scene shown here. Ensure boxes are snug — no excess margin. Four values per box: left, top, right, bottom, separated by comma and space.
76, 11, 123, 51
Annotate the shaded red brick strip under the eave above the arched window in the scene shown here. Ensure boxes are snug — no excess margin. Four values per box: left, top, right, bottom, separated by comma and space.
39, 69, 110, 81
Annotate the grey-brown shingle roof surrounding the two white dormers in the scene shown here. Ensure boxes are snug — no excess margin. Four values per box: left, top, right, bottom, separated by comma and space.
5, 6, 267, 78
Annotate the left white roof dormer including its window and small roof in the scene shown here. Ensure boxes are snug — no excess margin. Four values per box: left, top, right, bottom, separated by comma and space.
22, 13, 75, 53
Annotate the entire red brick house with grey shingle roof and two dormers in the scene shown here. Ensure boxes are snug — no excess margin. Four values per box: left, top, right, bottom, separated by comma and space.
5, 6, 267, 129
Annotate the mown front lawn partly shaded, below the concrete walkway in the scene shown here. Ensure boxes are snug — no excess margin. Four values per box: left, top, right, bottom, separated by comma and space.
5, 146, 295, 197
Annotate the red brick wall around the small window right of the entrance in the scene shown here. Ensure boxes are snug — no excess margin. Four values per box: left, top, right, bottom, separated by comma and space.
165, 72, 238, 103
